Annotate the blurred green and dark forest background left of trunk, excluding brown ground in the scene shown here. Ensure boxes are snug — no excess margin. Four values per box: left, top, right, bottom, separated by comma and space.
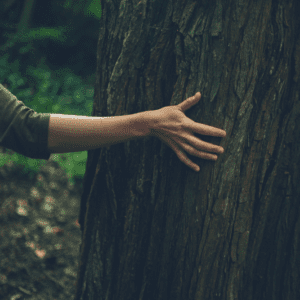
0, 0, 102, 182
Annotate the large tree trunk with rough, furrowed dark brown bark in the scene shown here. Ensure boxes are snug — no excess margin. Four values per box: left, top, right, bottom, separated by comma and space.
75, 0, 300, 300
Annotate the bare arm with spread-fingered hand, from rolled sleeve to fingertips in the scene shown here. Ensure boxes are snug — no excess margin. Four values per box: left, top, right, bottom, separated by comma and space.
48, 92, 226, 171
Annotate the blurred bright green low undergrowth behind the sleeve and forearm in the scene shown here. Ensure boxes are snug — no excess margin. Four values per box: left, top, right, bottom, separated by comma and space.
0, 54, 94, 183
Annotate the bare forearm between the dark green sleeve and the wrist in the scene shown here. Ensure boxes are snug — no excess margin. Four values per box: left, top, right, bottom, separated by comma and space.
48, 112, 150, 153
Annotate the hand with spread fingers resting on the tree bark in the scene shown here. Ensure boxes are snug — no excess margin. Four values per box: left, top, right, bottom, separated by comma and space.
150, 92, 226, 172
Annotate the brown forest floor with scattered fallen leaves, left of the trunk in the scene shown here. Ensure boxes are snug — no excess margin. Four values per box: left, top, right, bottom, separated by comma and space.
0, 146, 82, 300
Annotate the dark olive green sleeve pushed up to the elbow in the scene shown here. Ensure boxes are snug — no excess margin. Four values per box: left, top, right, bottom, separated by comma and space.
0, 84, 51, 160
